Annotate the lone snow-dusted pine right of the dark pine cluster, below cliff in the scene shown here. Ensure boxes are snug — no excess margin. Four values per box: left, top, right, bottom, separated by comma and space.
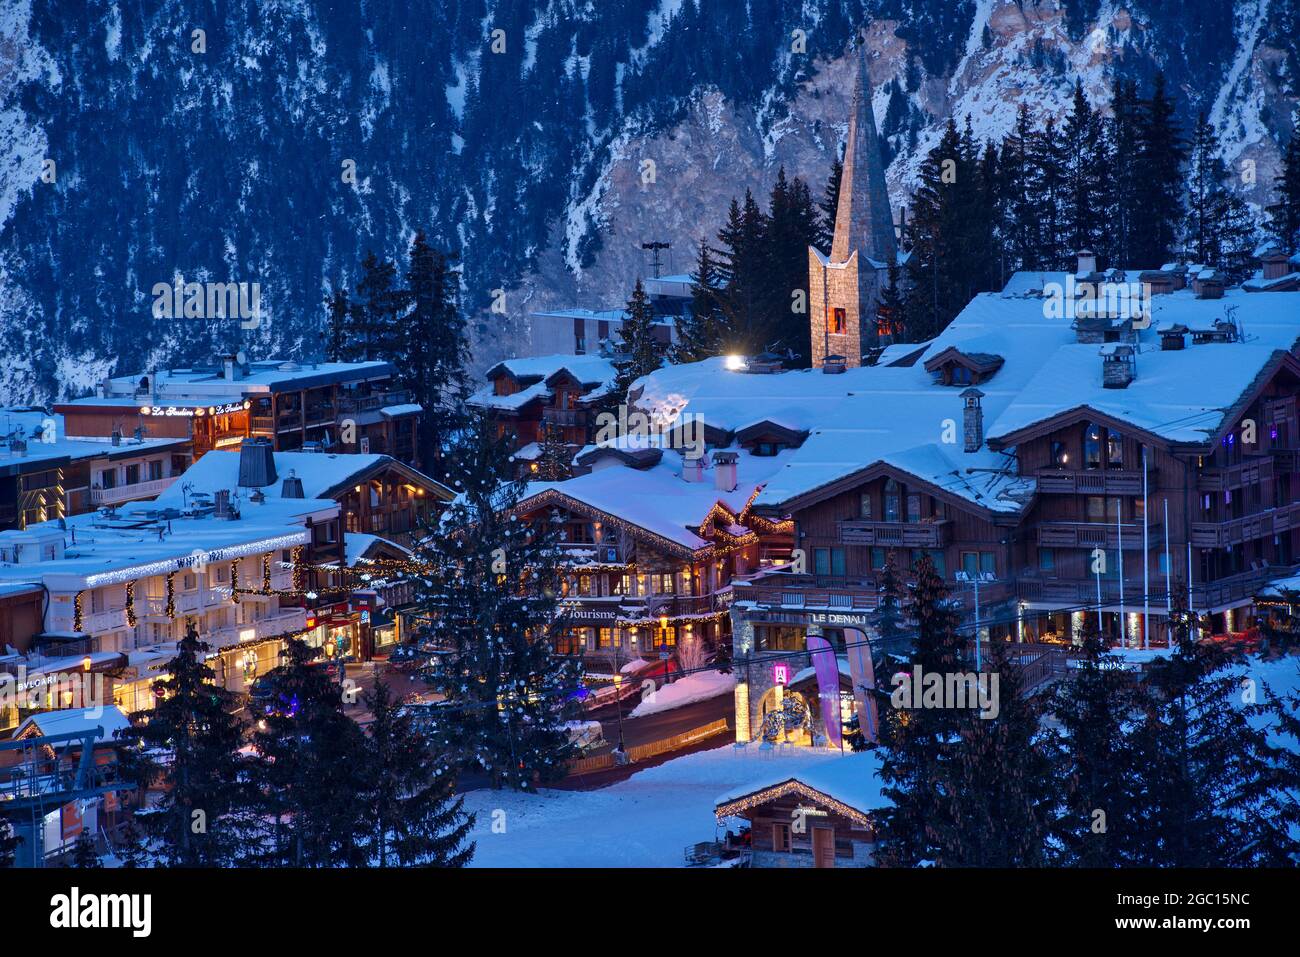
1183, 113, 1255, 282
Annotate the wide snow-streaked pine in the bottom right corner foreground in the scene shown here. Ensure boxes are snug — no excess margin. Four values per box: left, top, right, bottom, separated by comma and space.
1132, 605, 1295, 867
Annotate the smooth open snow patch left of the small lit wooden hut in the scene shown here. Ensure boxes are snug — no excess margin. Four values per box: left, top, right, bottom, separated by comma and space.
464, 745, 840, 867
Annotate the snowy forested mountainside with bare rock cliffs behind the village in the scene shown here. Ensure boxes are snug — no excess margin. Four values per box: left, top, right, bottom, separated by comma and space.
0, 0, 1300, 402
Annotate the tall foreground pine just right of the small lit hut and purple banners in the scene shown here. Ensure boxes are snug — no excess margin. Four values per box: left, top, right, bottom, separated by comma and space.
875, 546, 965, 867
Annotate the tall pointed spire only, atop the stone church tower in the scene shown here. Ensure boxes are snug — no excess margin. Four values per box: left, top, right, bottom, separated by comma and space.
831, 34, 897, 264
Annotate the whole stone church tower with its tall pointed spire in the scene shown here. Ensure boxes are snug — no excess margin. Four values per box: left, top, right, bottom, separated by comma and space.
809, 35, 897, 368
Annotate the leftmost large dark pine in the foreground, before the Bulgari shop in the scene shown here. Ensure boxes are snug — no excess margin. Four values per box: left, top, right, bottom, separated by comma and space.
122, 624, 250, 867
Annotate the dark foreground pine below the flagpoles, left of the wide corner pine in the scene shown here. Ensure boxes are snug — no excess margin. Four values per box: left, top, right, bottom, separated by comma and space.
1048, 635, 1138, 867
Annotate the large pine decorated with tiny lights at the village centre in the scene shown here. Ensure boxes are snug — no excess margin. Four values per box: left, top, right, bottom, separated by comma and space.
413, 417, 581, 791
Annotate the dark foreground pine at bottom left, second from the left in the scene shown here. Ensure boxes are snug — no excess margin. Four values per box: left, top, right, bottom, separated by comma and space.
252, 638, 369, 867
